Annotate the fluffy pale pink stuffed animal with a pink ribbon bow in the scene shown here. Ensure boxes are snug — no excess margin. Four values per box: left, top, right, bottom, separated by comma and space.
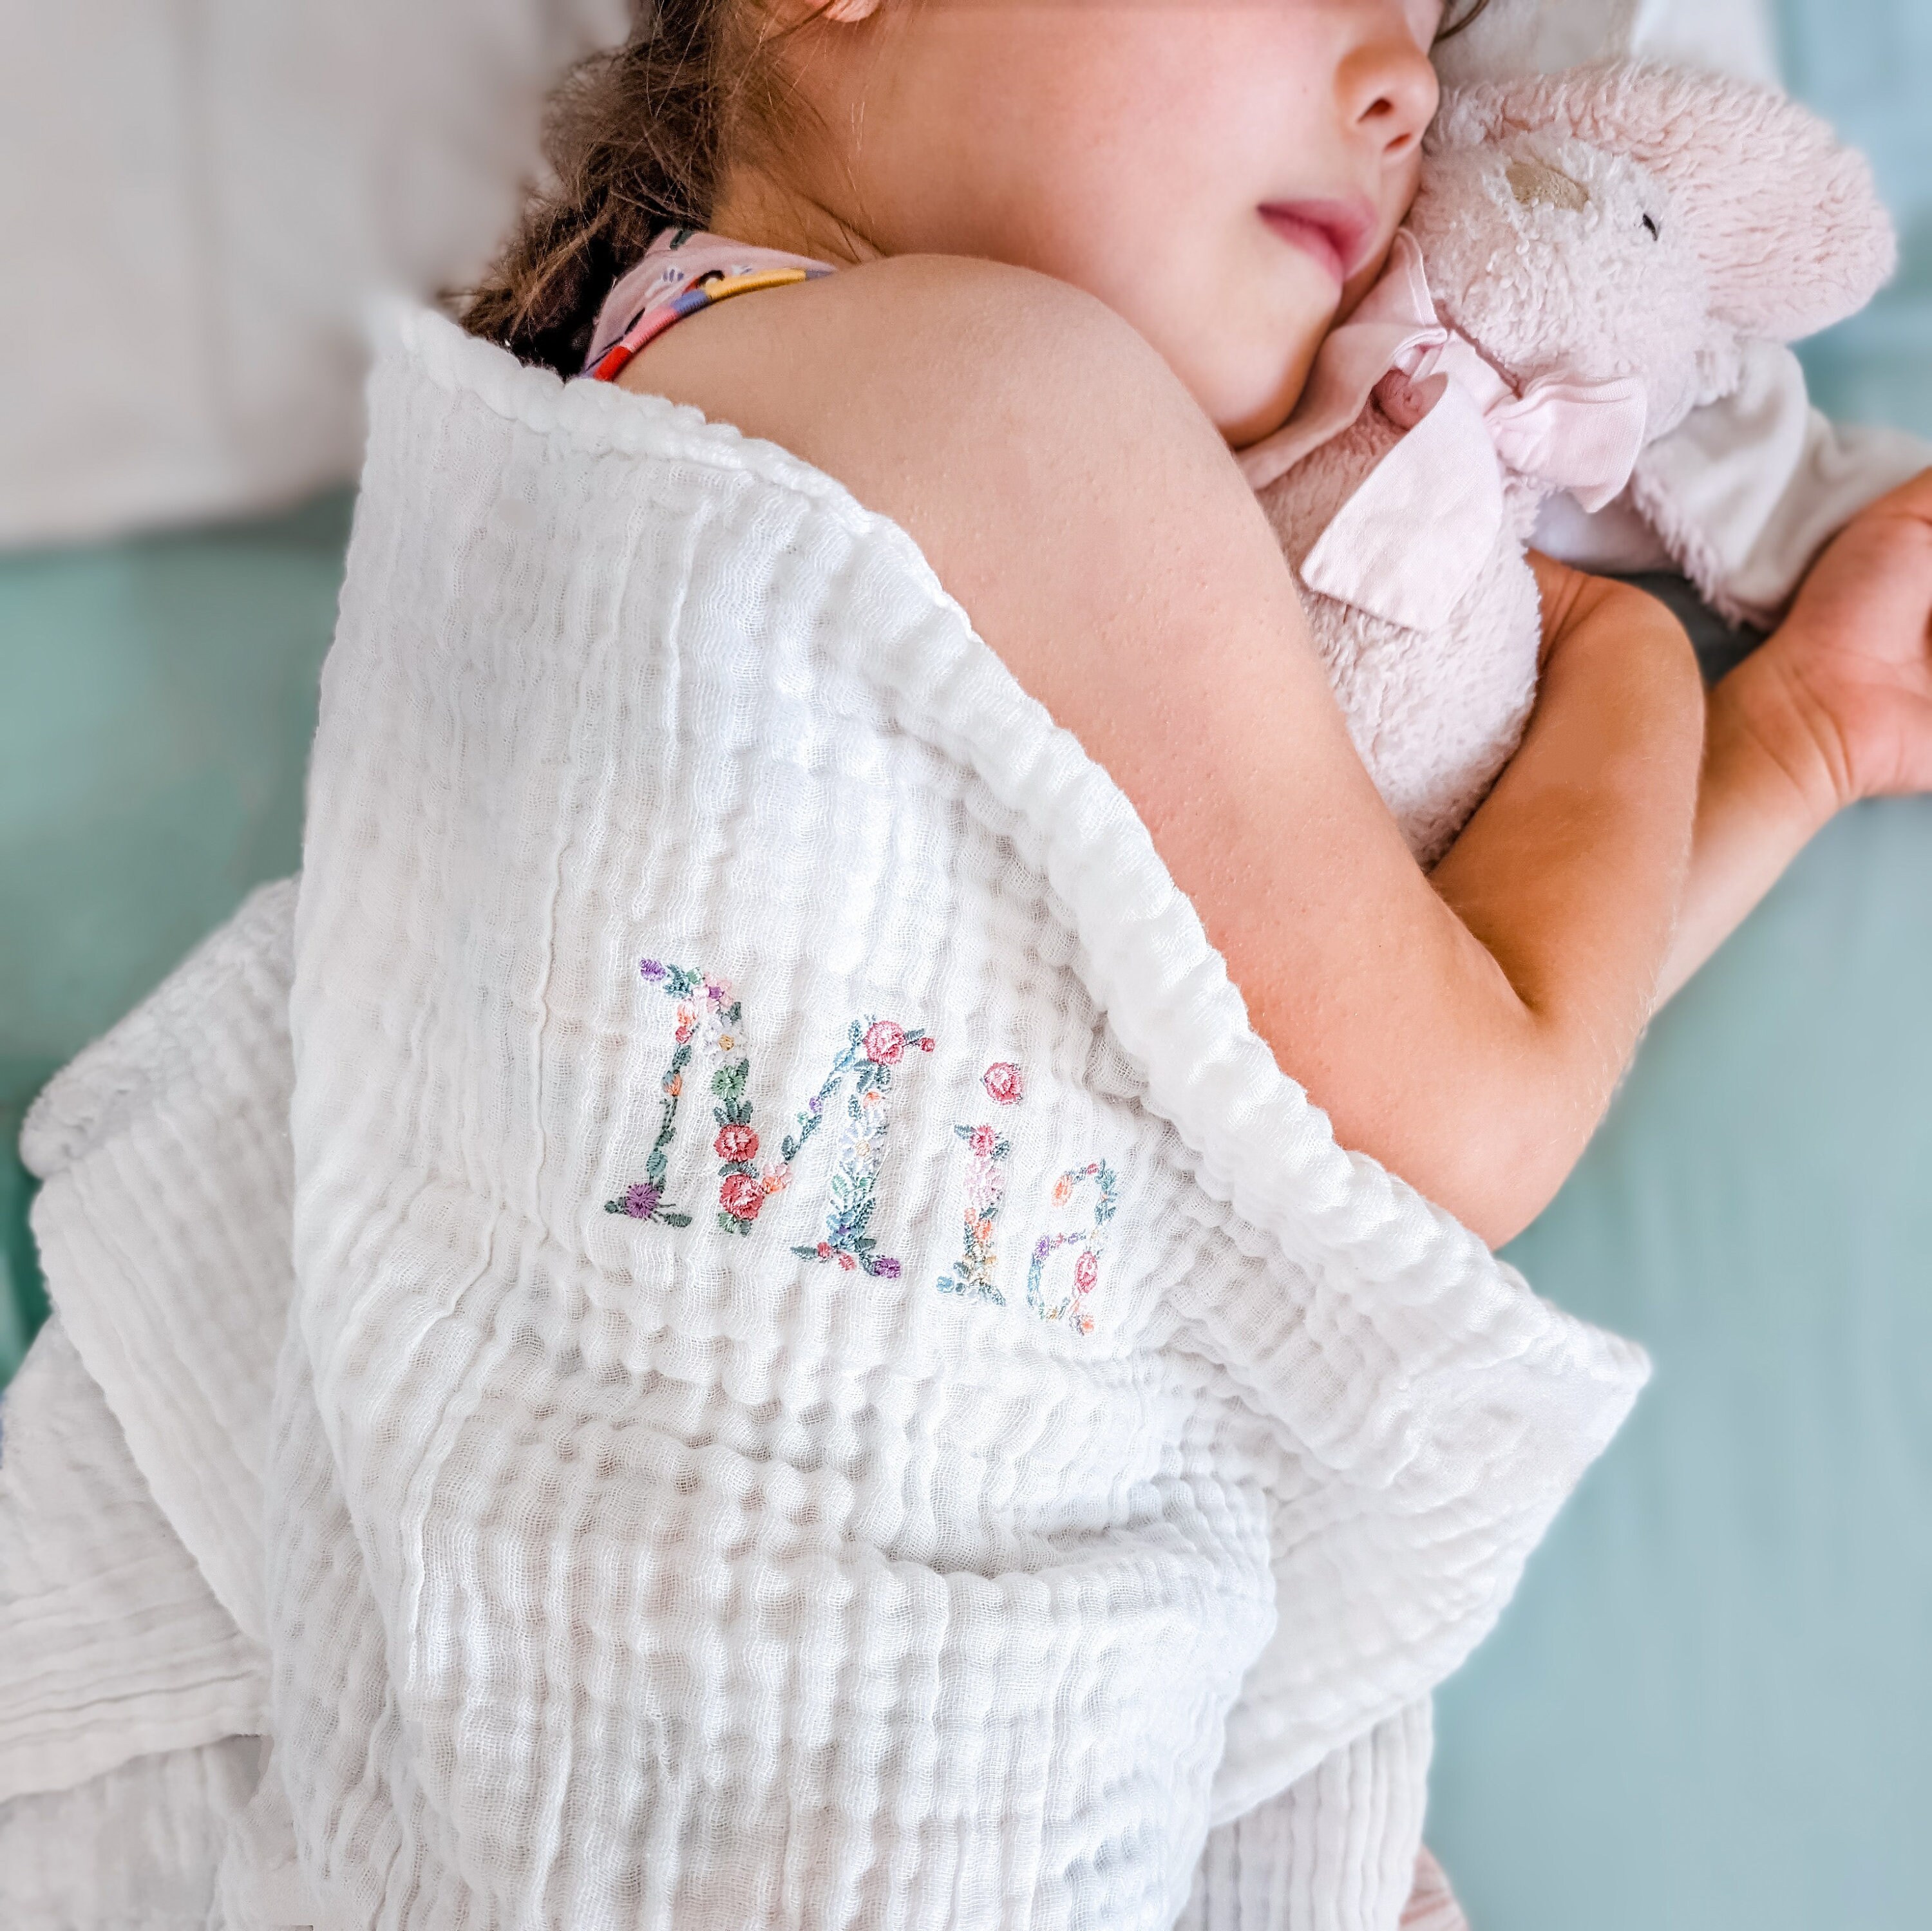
1242, 64, 1895, 865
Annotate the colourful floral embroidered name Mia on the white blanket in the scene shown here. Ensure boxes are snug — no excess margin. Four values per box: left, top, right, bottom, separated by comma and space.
605, 960, 1119, 1334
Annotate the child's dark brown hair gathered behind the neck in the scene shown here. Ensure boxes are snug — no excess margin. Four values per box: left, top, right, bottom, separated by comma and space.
458, 0, 1490, 375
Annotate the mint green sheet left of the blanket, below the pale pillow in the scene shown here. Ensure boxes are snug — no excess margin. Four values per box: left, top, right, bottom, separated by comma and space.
0, 495, 350, 1382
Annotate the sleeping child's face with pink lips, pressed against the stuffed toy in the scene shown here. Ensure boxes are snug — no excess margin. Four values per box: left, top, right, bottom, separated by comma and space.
746, 0, 1441, 448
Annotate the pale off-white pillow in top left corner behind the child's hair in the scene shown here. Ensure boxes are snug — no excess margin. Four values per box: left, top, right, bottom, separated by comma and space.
0, 0, 624, 545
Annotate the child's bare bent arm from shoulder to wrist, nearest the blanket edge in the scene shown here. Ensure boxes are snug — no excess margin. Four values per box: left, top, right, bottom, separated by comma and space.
651, 257, 1704, 1241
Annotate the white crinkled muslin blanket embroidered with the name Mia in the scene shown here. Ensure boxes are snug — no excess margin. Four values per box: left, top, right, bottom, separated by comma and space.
7, 311, 1646, 1931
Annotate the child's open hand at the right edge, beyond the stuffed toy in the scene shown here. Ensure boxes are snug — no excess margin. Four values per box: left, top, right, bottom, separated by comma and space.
1747, 469, 1932, 817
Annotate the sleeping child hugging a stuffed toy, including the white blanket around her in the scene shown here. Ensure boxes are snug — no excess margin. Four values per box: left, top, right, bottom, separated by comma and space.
0, 0, 1932, 1931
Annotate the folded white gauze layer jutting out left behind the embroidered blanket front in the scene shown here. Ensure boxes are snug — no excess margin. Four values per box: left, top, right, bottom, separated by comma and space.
8, 881, 296, 1643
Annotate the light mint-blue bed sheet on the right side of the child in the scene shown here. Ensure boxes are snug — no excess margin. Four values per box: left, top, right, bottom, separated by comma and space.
1430, 15, 1932, 1931
